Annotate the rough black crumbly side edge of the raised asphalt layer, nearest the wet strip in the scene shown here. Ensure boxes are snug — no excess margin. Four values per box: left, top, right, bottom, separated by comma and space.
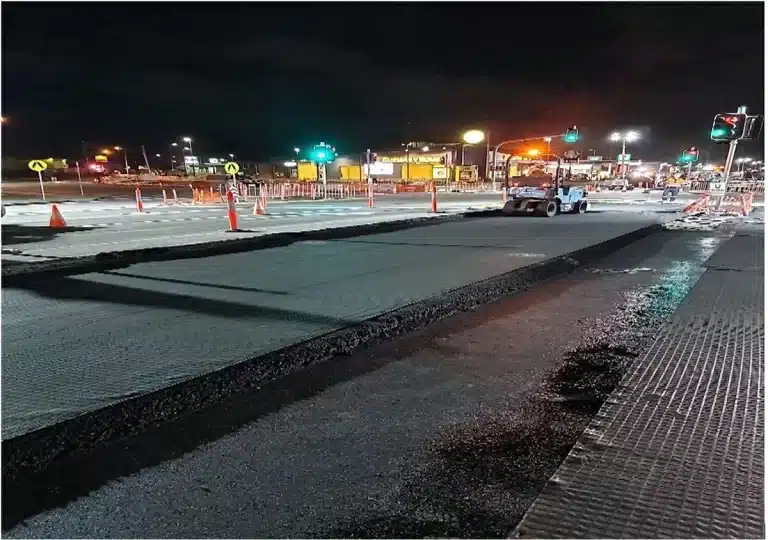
2, 221, 661, 482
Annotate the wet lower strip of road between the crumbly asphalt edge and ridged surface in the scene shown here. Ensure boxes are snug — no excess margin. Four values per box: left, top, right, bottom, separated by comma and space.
3, 227, 726, 538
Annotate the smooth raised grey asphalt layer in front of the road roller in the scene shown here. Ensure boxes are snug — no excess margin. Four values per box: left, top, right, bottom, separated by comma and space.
2, 207, 675, 439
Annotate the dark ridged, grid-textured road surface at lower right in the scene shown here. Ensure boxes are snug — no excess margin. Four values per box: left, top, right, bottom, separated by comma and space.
515, 237, 765, 538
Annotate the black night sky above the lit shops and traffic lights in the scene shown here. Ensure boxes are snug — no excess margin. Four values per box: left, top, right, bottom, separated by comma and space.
2, 2, 764, 160
